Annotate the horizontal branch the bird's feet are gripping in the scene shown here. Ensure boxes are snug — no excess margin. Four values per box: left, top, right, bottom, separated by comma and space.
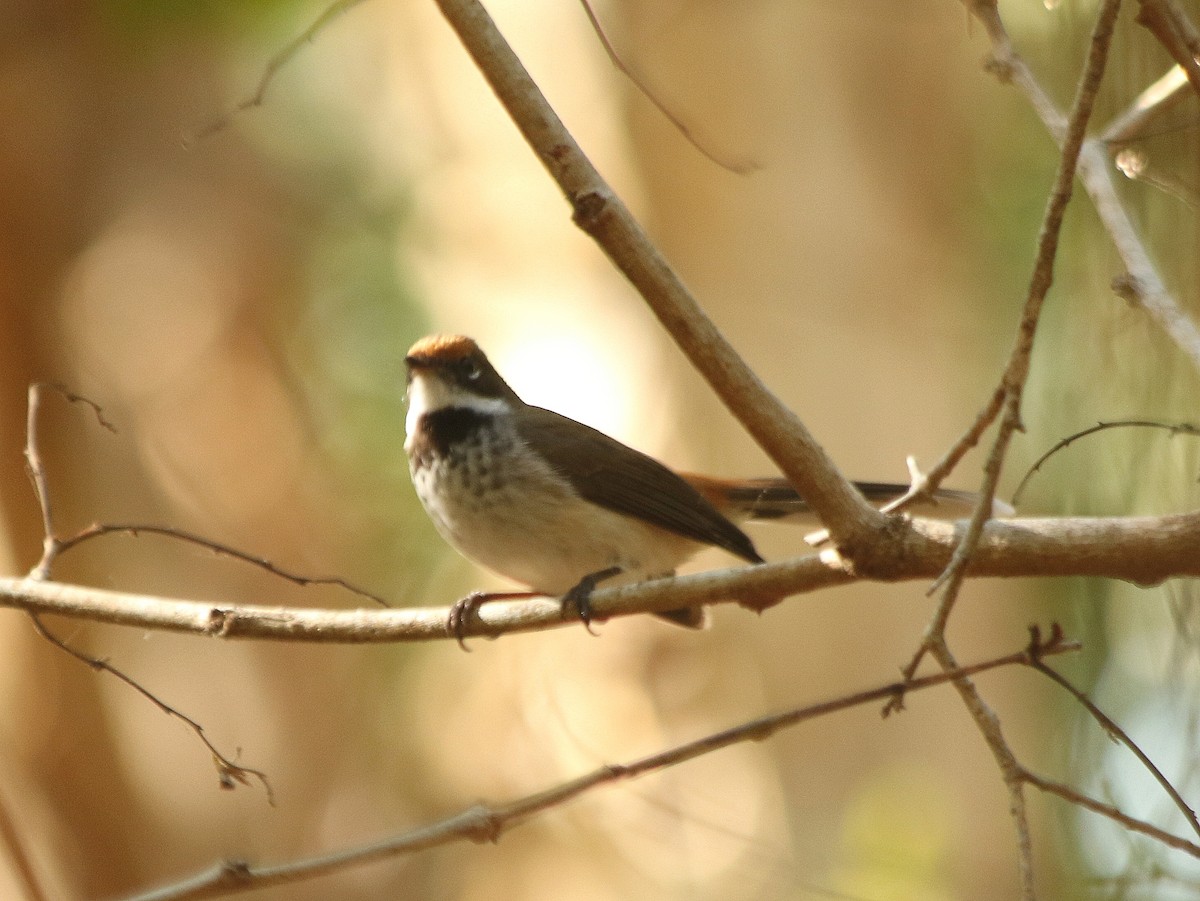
0, 513, 1200, 644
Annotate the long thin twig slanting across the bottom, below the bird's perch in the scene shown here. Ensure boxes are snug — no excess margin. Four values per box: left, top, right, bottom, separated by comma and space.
119, 631, 1079, 901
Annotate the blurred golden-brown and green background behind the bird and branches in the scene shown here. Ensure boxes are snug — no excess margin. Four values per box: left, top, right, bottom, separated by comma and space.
0, 0, 1200, 901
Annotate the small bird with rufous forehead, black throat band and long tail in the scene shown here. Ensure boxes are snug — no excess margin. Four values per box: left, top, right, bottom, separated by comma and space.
404, 335, 998, 648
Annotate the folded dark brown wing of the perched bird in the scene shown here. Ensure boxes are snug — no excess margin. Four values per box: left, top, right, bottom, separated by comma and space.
517, 407, 762, 563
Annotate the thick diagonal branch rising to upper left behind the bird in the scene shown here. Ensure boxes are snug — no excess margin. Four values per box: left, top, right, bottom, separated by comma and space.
438, 0, 884, 557
